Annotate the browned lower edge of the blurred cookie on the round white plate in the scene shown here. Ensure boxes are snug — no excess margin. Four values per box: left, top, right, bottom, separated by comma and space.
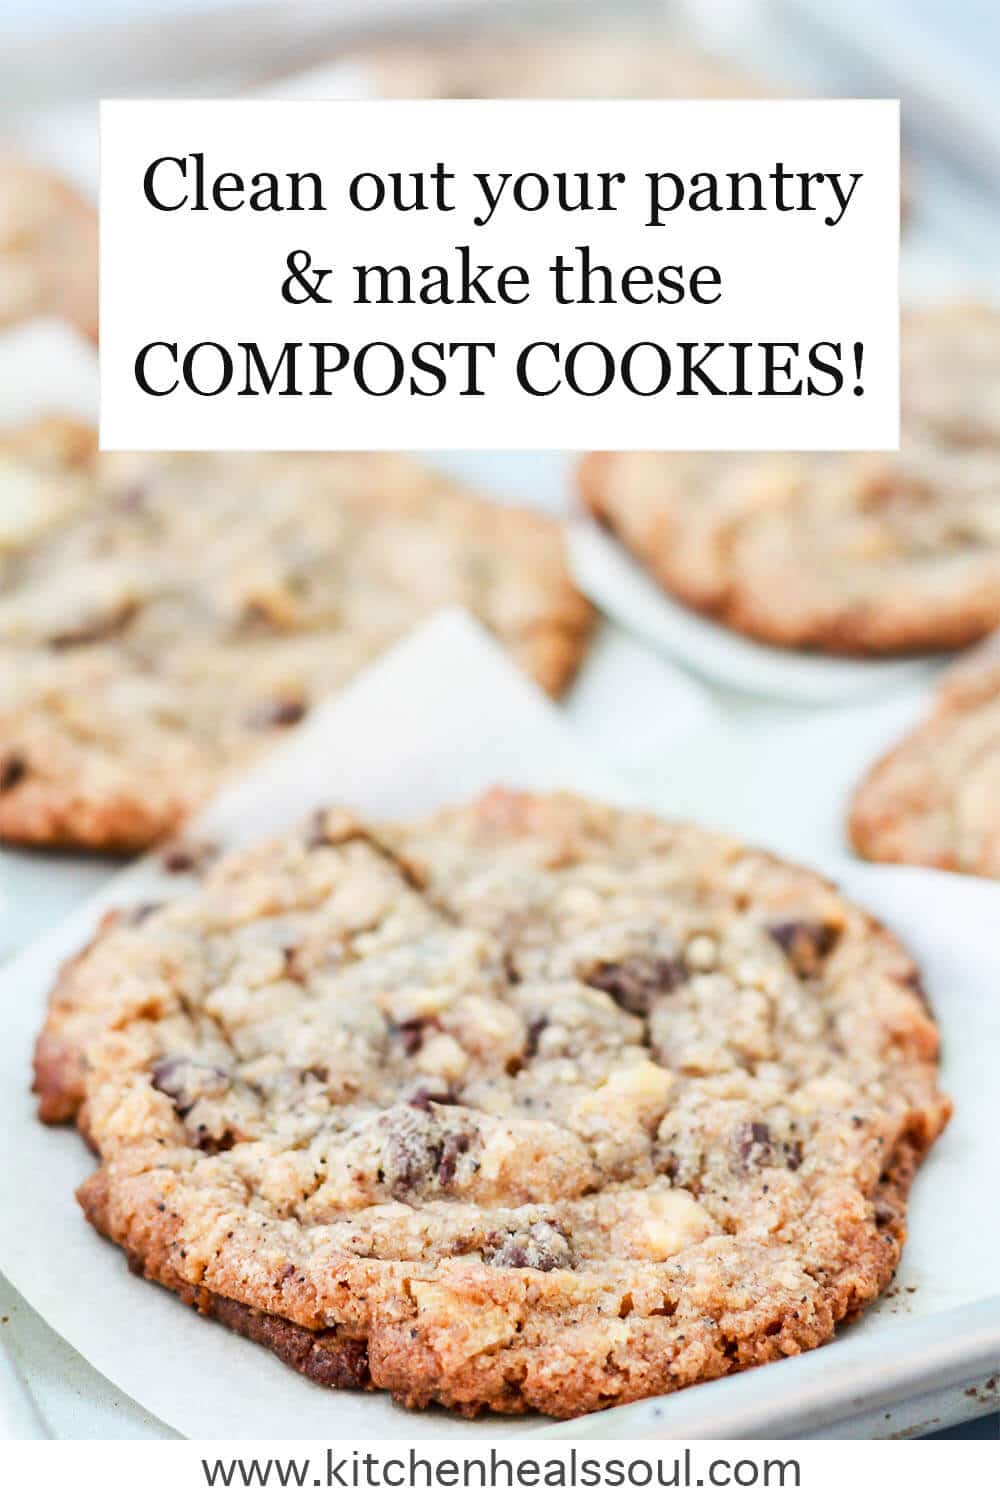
576, 453, 1000, 660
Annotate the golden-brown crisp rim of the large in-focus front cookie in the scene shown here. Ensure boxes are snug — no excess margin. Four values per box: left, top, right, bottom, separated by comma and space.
36, 791, 951, 1418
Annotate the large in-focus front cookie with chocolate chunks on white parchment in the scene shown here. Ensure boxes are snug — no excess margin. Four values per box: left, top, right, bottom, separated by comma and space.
36, 791, 949, 1418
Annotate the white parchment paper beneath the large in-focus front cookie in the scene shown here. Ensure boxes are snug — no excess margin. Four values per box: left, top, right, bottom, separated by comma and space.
0, 612, 1000, 1440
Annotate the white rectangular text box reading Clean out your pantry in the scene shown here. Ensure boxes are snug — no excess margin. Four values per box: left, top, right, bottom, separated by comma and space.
100, 101, 900, 449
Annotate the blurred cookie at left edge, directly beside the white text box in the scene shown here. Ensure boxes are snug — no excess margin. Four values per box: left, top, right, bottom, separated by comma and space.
0, 155, 97, 341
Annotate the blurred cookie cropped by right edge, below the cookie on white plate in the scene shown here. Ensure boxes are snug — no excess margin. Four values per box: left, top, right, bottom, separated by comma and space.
850, 657, 1000, 881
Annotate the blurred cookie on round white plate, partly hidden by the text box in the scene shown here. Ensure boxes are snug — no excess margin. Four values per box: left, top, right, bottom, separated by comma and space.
580, 308, 1000, 656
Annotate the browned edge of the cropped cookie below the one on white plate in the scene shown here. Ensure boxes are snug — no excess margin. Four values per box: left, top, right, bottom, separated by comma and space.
846, 659, 1000, 879
